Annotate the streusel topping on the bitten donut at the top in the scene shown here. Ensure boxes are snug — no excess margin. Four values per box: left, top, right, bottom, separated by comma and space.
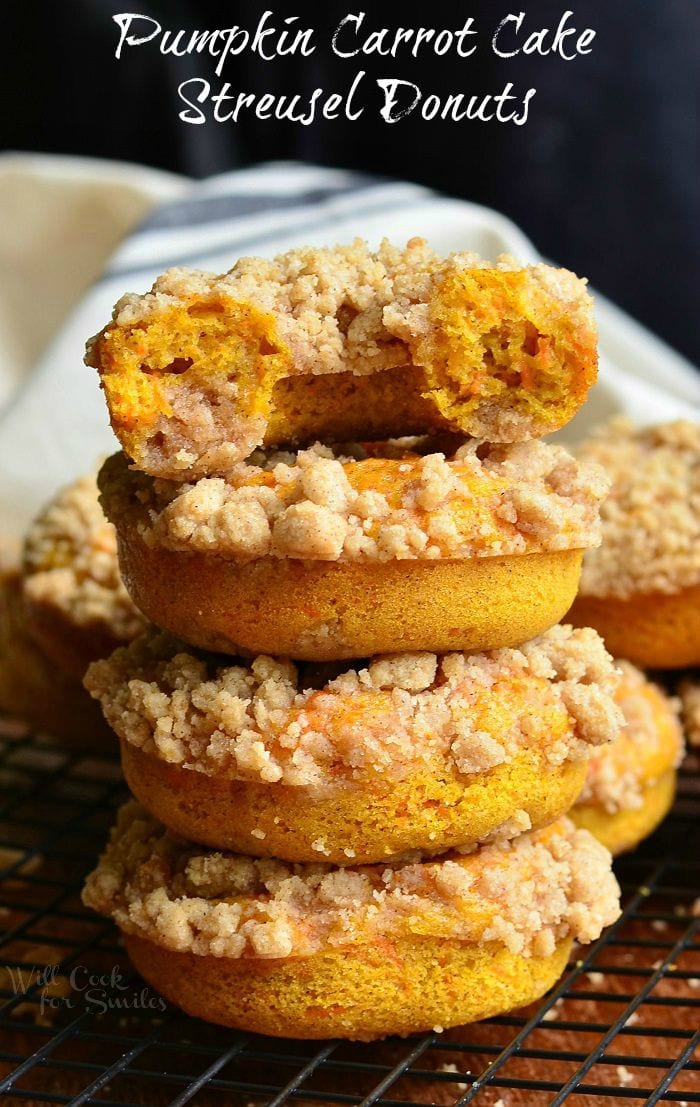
98, 238, 590, 374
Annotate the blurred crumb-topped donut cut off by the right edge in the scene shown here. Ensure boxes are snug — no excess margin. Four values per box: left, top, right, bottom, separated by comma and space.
569, 420, 700, 669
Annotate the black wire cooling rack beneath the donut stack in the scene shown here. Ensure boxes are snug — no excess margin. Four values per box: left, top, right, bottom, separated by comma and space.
0, 726, 700, 1107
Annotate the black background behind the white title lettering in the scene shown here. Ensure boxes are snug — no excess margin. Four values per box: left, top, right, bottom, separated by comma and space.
0, 0, 700, 361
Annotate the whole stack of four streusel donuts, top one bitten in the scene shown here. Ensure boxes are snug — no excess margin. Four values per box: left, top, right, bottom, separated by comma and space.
84, 239, 633, 1041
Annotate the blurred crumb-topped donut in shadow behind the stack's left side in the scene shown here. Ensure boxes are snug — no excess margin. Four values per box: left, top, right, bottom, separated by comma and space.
0, 476, 145, 746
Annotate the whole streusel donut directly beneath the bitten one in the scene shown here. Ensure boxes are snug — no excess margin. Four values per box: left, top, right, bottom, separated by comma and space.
100, 441, 607, 661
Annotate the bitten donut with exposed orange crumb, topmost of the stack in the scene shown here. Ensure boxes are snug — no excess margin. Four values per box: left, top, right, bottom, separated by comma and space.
86, 238, 597, 480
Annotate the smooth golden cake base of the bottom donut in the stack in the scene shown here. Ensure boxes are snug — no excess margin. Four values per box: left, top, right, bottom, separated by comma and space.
124, 934, 572, 1042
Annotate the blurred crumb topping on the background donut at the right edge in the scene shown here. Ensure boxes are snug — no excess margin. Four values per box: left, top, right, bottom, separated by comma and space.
577, 418, 700, 600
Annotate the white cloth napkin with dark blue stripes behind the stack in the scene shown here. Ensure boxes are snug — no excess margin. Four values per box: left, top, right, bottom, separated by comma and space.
0, 156, 700, 546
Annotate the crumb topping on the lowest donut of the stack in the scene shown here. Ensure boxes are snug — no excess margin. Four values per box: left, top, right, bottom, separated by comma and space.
83, 803, 619, 958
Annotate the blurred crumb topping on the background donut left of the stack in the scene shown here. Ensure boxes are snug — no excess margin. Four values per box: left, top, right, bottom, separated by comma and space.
22, 476, 145, 642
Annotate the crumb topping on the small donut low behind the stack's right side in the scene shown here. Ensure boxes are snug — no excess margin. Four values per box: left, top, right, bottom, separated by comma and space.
578, 661, 683, 815
